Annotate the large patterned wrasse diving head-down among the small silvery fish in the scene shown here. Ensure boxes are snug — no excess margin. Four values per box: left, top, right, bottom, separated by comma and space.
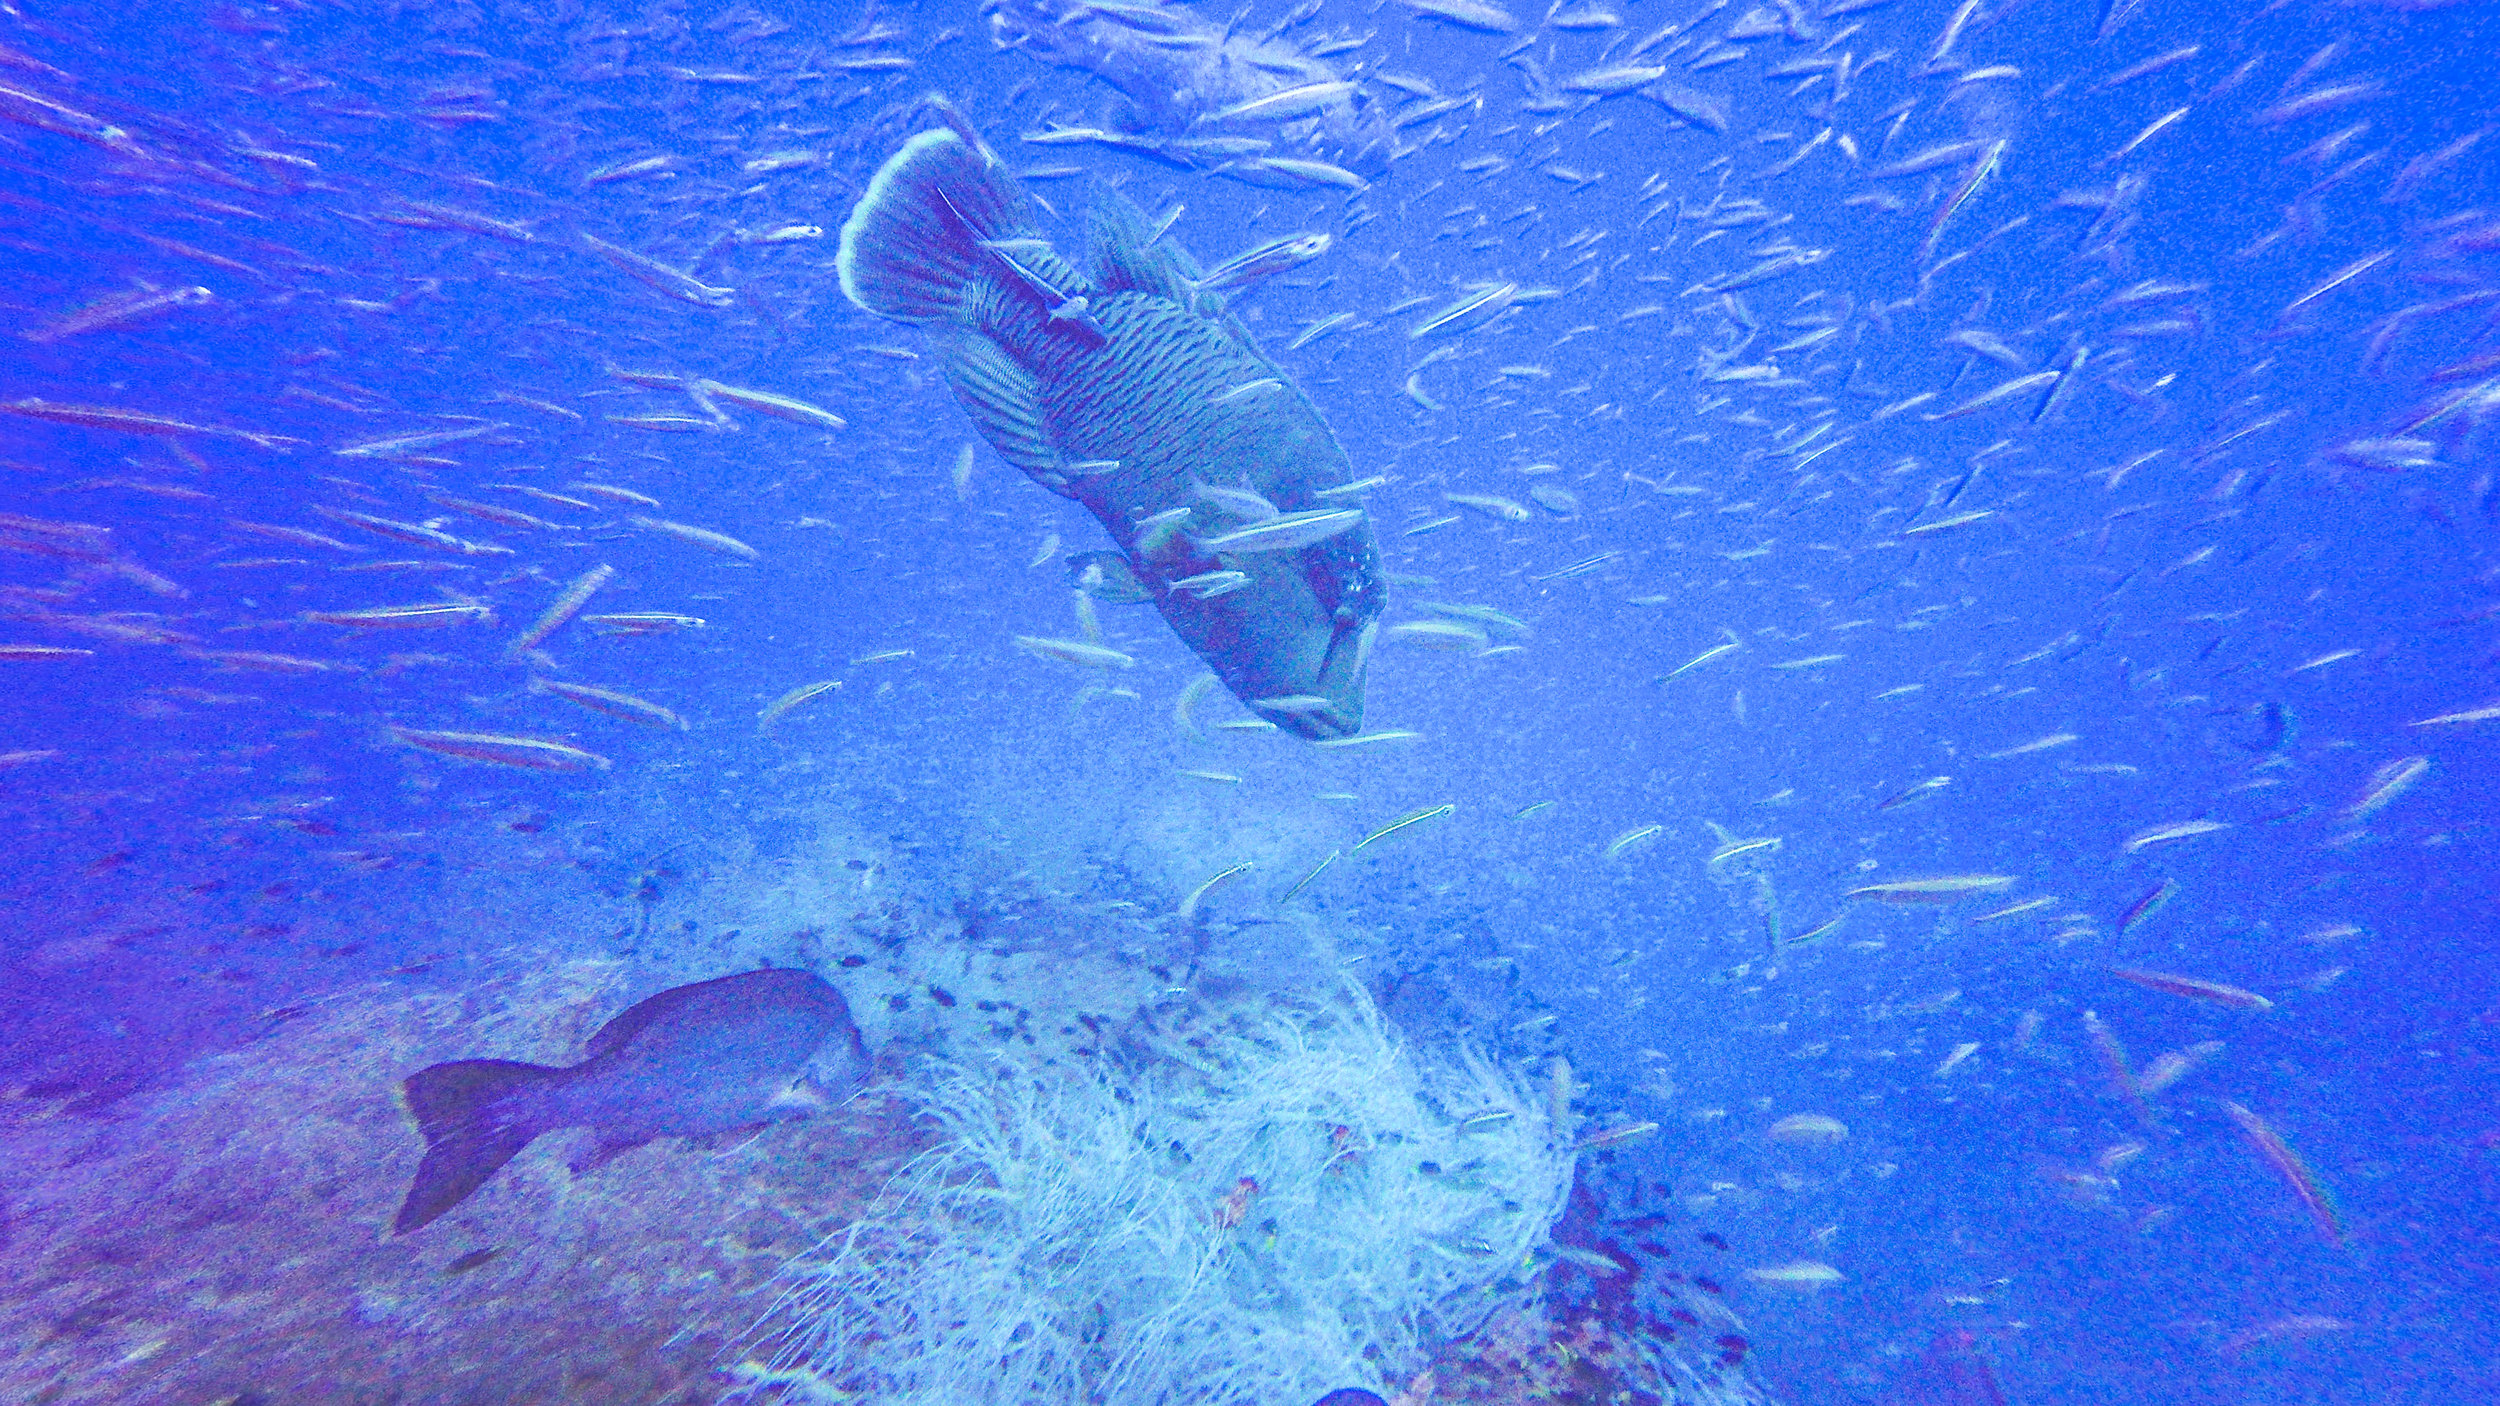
840, 110, 1388, 741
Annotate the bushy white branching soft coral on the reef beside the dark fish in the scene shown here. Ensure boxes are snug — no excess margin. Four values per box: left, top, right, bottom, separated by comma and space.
740, 986, 1573, 1406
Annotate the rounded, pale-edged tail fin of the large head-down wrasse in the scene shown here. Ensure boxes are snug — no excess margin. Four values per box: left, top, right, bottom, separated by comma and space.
835, 130, 1038, 323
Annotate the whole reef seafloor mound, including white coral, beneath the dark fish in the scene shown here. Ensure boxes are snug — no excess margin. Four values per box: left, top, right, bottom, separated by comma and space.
0, 820, 1763, 1406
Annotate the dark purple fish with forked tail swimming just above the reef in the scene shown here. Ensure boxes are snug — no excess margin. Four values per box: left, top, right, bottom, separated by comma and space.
390, 971, 868, 1236
